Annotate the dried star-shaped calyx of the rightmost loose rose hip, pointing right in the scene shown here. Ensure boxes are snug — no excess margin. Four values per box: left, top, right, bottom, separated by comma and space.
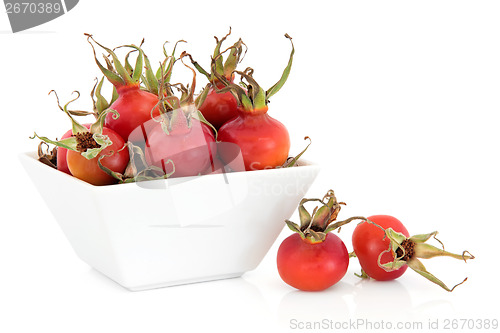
378, 228, 474, 291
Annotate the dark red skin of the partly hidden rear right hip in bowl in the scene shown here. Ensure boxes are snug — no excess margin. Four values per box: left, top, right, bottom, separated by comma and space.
199, 87, 238, 130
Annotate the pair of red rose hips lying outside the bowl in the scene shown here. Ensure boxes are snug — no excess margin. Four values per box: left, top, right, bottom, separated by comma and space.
277, 190, 474, 291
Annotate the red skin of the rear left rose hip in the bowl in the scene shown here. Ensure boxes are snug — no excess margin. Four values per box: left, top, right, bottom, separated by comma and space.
104, 85, 159, 141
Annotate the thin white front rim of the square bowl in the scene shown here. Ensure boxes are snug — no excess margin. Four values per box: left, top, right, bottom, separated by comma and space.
18, 151, 320, 190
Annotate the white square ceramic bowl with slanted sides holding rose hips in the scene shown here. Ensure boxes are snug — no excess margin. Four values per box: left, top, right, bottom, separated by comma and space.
20, 152, 319, 290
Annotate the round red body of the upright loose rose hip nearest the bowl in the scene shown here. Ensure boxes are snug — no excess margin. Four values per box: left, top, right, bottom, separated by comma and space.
277, 233, 349, 291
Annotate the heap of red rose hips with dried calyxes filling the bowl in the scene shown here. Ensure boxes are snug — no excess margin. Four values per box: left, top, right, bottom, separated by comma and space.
33, 30, 294, 185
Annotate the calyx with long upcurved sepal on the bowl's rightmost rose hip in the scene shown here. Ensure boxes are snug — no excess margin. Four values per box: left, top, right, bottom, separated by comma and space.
212, 34, 295, 112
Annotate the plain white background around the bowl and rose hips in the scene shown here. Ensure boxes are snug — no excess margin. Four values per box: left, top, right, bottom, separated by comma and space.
0, 0, 500, 333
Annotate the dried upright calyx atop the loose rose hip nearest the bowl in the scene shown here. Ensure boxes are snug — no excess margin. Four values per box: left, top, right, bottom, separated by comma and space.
285, 190, 366, 244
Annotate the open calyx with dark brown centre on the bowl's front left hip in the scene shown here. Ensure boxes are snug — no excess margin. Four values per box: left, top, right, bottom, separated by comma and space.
32, 90, 119, 159
